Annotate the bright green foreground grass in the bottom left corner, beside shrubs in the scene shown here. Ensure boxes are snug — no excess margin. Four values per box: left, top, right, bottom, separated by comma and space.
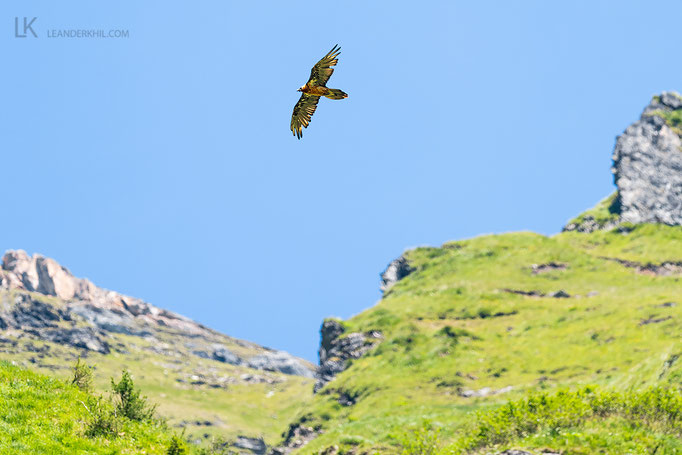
0, 362, 171, 455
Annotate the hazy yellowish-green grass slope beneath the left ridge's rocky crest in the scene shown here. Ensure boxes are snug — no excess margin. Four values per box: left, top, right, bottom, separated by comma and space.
0, 324, 313, 443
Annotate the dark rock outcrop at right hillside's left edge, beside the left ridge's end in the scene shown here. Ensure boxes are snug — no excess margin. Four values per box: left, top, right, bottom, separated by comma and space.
314, 319, 383, 392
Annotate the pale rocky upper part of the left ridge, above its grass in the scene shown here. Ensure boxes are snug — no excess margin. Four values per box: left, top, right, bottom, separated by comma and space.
0, 250, 315, 377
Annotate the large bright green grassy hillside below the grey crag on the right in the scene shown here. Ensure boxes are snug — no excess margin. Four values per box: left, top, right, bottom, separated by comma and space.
296, 209, 682, 454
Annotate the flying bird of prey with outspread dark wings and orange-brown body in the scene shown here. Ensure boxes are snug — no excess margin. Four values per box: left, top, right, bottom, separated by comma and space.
291, 44, 348, 139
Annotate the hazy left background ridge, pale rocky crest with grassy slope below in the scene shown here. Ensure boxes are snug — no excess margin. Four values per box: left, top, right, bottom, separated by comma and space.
0, 250, 316, 448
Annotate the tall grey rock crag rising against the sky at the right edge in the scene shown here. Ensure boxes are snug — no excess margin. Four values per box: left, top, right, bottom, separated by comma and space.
613, 92, 682, 225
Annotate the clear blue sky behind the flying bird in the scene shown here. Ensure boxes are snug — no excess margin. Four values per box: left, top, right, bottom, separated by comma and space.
0, 0, 682, 360
